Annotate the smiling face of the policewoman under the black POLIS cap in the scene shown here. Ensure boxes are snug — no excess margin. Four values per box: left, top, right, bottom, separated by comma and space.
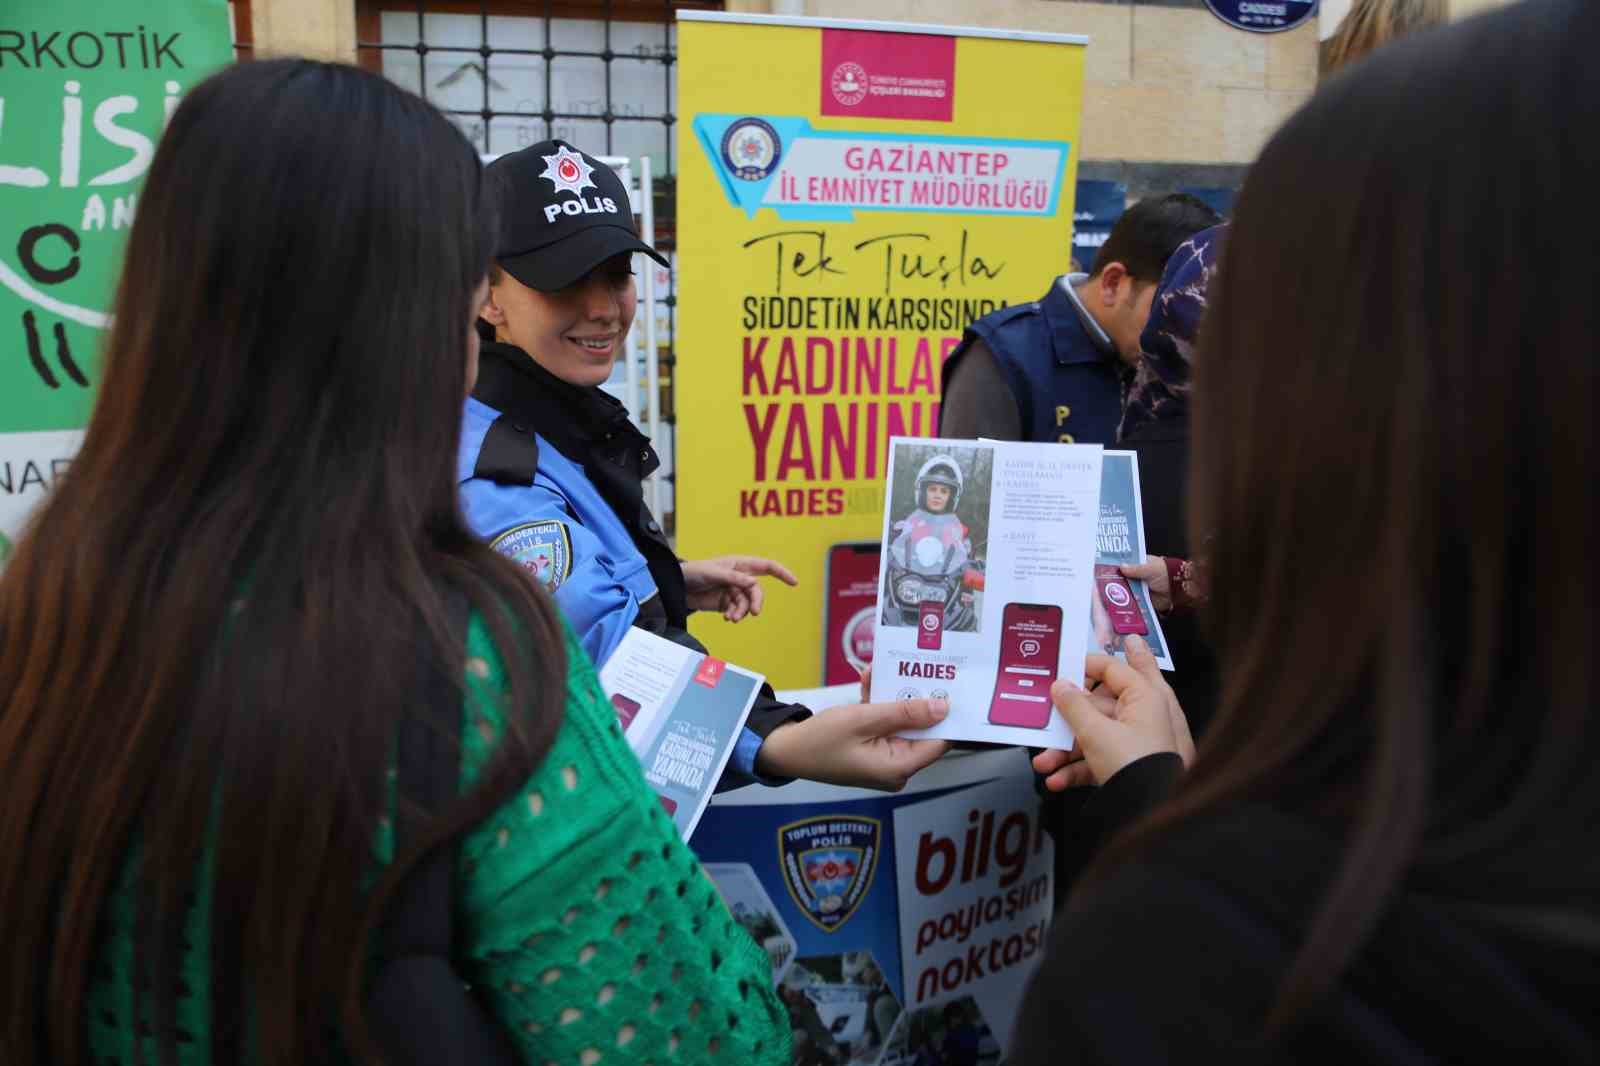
482, 254, 637, 386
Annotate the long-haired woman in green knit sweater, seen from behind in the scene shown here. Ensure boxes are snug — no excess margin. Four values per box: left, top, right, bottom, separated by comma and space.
0, 61, 789, 1066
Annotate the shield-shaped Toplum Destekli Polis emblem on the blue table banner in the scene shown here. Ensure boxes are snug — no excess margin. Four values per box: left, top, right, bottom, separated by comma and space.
778, 815, 883, 933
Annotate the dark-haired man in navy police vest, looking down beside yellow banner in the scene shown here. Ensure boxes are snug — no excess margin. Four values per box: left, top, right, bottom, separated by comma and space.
939, 192, 1222, 445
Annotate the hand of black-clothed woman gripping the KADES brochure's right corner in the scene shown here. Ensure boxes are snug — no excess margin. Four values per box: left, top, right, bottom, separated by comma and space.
1034, 637, 1195, 791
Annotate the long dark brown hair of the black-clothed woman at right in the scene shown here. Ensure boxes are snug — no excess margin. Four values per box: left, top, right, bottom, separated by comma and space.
1107, 0, 1600, 1031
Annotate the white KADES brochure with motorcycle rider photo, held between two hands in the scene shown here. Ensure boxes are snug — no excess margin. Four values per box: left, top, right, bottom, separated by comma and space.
872, 437, 1101, 747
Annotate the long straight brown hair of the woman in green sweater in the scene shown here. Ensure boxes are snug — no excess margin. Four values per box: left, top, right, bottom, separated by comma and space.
0, 59, 565, 1066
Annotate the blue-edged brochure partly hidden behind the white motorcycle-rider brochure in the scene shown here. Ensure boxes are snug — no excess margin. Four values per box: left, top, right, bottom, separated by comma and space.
1085, 451, 1173, 671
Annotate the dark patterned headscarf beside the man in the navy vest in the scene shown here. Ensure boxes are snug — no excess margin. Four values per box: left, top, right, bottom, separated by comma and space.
1117, 224, 1227, 440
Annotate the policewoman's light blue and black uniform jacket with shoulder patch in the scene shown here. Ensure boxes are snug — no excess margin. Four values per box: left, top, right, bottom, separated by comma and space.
458, 343, 810, 784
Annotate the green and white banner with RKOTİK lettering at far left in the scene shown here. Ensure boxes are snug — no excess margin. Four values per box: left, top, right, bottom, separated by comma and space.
0, 0, 234, 547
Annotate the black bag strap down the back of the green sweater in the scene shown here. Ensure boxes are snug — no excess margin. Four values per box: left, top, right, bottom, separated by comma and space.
366, 592, 522, 1066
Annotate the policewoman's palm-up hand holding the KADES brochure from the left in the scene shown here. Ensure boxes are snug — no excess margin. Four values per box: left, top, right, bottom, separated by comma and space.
755, 681, 950, 792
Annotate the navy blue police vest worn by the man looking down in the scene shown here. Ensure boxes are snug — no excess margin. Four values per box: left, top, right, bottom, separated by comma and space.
944, 275, 1126, 445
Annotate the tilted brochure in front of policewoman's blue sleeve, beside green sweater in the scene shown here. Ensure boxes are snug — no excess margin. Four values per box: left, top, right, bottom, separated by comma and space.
600, 626, 762, 840
